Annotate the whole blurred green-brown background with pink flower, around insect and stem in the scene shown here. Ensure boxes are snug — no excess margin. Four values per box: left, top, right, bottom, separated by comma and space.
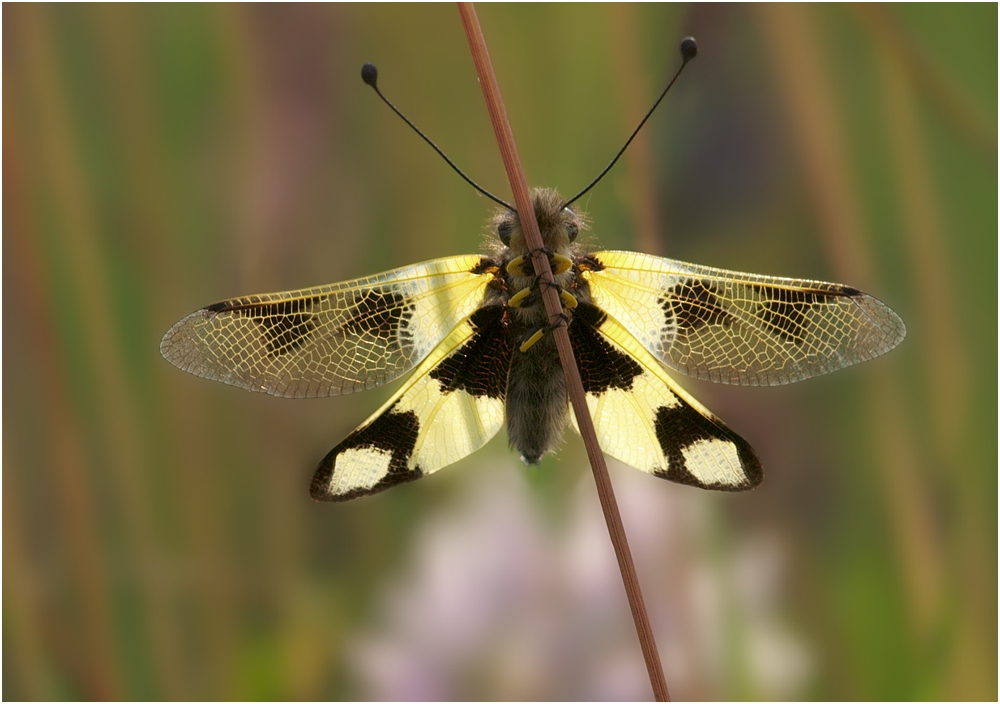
3, 4, 997, 700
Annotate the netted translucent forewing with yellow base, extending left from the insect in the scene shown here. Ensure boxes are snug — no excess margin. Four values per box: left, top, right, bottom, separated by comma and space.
160, 255, 492, 398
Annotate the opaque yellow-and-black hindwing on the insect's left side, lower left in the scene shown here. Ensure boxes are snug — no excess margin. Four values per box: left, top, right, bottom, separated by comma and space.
312, 306, 513, 501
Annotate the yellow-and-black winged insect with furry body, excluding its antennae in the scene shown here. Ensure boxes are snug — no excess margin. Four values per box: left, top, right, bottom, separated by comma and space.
160, 190, 905, 501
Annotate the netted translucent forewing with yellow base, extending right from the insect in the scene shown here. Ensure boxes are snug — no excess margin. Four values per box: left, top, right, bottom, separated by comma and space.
582, 252, 906, 386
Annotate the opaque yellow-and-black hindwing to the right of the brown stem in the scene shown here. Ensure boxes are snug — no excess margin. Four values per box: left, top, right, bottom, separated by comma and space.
570, 303, 764, 491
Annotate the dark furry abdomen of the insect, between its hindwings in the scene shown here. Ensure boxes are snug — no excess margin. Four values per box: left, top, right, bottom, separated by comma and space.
506, 335, 568, 464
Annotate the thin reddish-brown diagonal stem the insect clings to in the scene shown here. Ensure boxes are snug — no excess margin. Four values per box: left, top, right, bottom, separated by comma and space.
458, 3, 670, 701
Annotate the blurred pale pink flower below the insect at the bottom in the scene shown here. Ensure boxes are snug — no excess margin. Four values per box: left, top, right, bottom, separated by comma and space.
353, 456, 810, 700
